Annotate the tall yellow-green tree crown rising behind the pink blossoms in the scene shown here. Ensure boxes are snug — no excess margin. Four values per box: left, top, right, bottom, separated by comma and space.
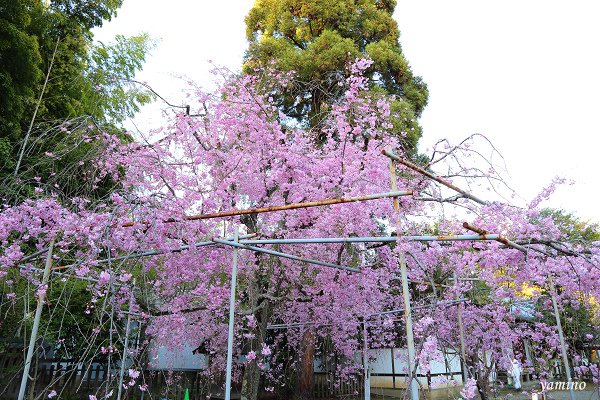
244, 0, 428, 153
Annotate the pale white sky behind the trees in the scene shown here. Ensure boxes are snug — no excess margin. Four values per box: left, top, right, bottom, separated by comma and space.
95, 0, 600, 222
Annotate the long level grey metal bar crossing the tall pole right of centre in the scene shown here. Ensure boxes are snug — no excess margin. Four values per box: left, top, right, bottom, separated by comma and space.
240, 234, 500, 244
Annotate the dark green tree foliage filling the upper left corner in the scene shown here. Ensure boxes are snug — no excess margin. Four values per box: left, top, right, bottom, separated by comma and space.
0, 0, 152, 203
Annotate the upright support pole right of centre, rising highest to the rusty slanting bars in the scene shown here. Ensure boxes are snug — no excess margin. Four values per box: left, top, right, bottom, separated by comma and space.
390, 159, 419, 400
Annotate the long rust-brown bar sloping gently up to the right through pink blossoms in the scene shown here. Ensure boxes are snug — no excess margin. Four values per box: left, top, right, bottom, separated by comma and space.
122, 190, 413, 227
